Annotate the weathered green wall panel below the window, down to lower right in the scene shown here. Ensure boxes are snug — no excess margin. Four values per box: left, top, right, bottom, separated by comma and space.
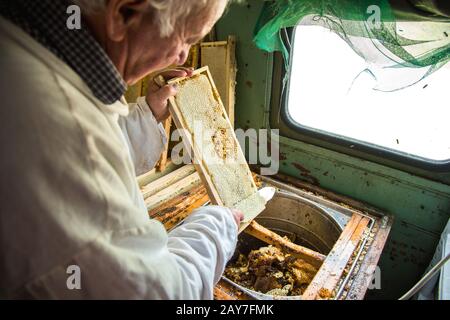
280, 138, 450, 299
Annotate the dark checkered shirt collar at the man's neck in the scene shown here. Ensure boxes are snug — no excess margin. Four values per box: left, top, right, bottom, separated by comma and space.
0, 0, 127, 104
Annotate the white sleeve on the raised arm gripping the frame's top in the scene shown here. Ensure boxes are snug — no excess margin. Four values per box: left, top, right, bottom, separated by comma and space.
119, 97, 167, 175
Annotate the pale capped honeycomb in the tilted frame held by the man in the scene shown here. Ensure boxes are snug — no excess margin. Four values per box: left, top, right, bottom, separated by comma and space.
175, 74, 265, 215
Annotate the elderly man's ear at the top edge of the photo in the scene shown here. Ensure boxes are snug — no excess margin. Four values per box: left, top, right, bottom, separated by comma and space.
105, 0, 149, 42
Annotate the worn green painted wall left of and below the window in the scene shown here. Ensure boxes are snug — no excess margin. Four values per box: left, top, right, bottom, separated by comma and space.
217, 0, 450, 299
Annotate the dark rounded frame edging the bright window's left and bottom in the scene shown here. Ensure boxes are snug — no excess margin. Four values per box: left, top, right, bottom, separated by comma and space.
270, 26, 450, 178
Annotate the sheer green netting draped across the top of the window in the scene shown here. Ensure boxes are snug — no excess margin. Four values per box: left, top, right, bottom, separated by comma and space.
254, 0, 450, 89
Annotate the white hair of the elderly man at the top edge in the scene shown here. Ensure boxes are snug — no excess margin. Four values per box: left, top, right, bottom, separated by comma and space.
72, 0, 232, 37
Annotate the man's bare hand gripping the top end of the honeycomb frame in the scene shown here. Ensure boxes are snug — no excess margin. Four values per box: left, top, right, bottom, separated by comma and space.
146, 67, 193, 122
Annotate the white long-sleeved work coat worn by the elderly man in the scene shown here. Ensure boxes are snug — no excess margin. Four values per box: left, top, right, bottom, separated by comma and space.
0, 18, 237, 299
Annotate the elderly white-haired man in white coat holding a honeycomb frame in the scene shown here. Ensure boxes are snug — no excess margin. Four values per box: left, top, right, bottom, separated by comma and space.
0, 0, 242, 299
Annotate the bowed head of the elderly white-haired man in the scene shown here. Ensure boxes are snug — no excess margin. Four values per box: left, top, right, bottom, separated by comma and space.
73, 0, 229, 84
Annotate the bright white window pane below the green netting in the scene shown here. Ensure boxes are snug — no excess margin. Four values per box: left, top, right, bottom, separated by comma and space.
287, 26, 450, 161
